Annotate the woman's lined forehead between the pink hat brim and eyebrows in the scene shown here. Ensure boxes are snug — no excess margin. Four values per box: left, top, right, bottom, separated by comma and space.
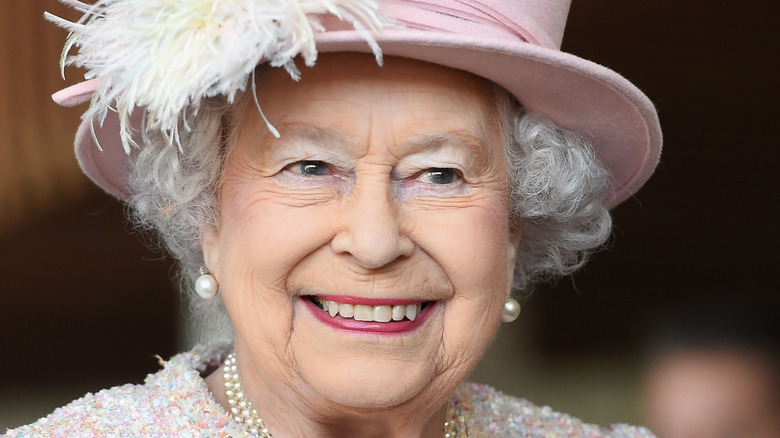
233, 53, 500, 153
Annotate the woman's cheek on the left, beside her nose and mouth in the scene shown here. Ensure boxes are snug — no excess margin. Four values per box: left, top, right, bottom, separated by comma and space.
217, 181, 342, 364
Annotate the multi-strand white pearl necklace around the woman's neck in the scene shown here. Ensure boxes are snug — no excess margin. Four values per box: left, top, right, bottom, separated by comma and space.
224, 353, 465, 438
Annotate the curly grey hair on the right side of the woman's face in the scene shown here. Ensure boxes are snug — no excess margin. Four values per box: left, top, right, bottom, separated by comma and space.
507, 115, 612, 291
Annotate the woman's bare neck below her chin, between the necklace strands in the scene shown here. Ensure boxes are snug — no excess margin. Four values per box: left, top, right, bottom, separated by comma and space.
206, 358, 449, 438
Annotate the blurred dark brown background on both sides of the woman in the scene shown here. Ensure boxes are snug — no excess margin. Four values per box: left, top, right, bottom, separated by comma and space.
0, 0, 780, 436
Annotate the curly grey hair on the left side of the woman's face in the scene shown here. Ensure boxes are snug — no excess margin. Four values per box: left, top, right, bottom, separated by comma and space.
127, 99, 240, 342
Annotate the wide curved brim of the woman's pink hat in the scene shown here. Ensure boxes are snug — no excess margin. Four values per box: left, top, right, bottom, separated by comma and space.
70, 29, 662, 207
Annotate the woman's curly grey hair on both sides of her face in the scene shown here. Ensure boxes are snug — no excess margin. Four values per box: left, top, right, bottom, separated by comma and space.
128, 80, 612, 341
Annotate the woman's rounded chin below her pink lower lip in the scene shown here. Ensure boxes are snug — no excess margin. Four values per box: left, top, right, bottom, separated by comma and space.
292, 302, 442, 409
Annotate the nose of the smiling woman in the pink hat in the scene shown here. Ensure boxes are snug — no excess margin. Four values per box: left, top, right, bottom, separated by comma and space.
331, 177, 414, 269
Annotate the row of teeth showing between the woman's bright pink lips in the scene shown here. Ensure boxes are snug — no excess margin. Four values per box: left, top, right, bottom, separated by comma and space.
306, 296, 434, 322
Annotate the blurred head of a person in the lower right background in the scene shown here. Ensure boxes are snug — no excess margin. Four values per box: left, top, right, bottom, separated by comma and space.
643, 311, 780, 438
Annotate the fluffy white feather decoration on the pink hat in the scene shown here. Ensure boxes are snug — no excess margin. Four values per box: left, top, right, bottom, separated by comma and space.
46, 0, 386, 154
